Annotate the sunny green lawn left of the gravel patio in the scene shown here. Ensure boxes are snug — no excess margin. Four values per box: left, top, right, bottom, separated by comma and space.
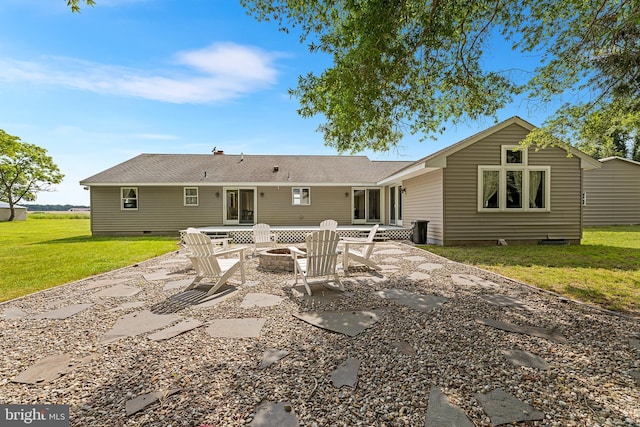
0, 214, 178, 301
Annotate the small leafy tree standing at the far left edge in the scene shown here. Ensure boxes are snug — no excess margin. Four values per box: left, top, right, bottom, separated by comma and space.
0, 129, 64, 221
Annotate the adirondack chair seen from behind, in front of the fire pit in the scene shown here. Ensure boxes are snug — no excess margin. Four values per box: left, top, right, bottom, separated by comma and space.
289, 230, 344, 295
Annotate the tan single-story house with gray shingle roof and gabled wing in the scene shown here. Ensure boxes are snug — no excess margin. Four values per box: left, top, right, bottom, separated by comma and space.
80, 117, 600, 245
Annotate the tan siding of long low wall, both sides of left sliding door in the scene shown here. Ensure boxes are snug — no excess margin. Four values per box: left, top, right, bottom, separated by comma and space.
91, 186, 358, 235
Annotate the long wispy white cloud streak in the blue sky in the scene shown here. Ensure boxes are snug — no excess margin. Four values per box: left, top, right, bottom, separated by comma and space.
0, 43, 277, 104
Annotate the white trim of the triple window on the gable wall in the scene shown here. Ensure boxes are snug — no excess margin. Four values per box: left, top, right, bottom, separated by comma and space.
477, 166, 551, 213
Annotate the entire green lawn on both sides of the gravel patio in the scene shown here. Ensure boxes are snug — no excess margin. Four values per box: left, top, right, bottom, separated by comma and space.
0, 219, 640, 316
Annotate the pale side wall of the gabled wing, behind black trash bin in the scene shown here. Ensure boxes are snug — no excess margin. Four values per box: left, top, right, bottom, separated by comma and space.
402, 169, 444, 244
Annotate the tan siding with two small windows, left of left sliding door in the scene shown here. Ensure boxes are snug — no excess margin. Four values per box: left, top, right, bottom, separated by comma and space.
91, 186, 223, 236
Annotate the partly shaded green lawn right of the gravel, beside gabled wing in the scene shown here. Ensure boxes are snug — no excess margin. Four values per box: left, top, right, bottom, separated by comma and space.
424, 226, 640, 316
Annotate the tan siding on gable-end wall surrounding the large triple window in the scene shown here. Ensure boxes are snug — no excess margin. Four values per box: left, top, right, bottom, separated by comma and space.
444, 124, 582, 244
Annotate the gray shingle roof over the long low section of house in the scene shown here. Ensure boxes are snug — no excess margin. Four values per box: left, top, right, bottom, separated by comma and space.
80, 154, 413, 185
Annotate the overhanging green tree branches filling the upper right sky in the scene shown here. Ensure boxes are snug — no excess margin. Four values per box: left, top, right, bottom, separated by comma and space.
67, 0, 640, 152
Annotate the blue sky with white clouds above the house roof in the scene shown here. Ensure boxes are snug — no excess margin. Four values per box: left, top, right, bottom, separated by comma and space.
0, 0, 548, 205
